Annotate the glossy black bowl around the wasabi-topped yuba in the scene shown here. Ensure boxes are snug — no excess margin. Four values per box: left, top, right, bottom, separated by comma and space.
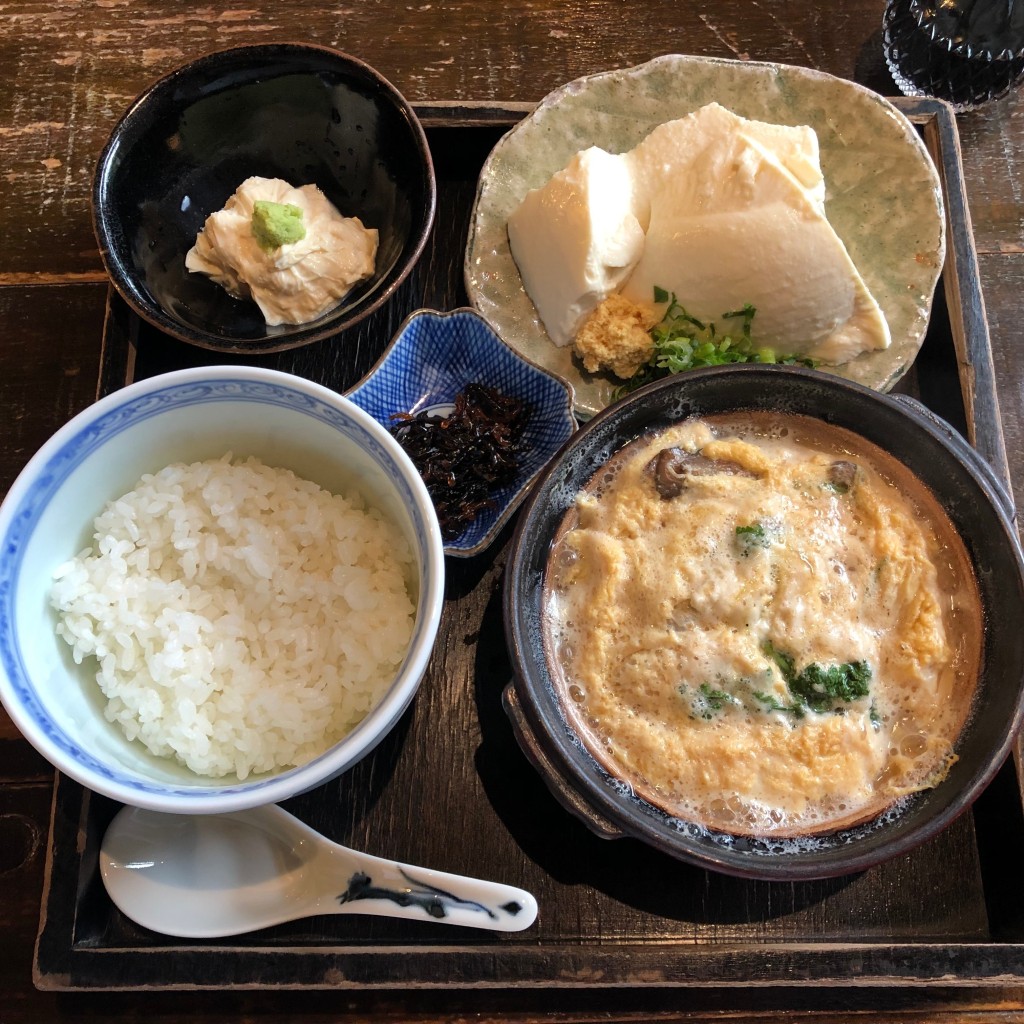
92, 43, 436, 353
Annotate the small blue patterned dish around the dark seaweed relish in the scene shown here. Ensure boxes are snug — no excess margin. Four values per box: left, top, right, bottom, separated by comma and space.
346, 309, 577, 558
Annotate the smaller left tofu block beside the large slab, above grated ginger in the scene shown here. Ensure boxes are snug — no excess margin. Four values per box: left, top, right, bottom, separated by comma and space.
508, 146, 644, 345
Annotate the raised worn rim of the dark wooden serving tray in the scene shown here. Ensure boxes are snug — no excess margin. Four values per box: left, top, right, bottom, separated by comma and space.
33, 97, 1024, 991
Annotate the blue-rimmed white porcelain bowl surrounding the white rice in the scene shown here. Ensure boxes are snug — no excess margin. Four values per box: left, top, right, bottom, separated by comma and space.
0, 367, 444, 813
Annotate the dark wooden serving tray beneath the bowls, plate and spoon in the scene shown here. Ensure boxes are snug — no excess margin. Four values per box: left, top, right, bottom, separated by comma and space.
35, 100, 1024, 991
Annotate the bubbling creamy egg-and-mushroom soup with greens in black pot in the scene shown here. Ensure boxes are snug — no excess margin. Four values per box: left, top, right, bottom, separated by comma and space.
545, 412, 982, 836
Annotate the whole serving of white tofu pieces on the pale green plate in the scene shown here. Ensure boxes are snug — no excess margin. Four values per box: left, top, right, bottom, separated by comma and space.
509, 103, 890, 364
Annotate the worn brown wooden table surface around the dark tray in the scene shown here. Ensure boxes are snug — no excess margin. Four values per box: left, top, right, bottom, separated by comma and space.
0, 0, 1024, 1024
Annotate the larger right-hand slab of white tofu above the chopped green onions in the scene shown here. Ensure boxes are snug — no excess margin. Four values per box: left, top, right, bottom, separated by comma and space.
622, 130, 890, 364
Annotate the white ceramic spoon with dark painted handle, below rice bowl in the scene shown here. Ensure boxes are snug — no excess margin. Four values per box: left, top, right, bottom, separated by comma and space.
99, 806, 537, 938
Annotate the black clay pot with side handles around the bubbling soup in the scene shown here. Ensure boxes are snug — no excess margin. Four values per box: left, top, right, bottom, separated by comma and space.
505, 367, 1024, 880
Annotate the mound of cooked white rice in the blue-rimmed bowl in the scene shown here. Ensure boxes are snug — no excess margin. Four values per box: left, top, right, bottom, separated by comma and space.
51, 455, 416, 779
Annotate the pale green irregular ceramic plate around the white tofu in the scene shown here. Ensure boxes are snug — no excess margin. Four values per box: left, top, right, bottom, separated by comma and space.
465, 54, 945, 416
